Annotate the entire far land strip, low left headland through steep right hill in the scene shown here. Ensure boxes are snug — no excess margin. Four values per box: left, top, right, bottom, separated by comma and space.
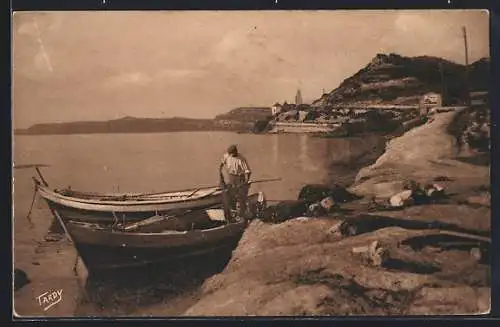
14, 54, 490, 135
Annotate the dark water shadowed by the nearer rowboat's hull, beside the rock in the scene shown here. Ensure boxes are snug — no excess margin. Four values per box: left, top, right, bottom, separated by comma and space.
76, 251, 231, 316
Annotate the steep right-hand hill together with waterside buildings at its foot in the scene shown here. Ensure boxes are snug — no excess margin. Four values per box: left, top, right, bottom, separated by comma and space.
256, 54, 489, 136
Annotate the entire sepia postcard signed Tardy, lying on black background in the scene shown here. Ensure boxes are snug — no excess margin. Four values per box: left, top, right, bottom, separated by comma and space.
12, 10, 491, 318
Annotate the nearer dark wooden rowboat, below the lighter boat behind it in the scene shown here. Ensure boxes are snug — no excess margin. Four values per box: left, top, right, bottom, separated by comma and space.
64, 209, 247, 273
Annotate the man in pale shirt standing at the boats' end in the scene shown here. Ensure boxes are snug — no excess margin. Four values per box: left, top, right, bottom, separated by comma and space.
219, 145, 252, 220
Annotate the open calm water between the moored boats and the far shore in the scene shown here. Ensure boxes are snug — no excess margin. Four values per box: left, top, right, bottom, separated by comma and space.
14, 132, 380, 199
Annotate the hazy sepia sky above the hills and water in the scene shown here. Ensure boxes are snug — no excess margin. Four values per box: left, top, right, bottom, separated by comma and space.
12, 10, 489, 128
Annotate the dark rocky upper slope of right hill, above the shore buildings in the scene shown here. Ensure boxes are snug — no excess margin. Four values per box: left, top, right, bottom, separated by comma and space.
313, 54, 490, 107
